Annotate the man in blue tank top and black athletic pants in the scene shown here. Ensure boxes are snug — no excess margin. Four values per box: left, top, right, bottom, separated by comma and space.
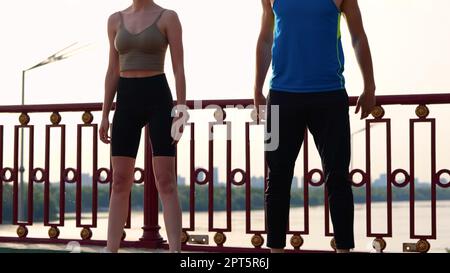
254, 0, 375, 253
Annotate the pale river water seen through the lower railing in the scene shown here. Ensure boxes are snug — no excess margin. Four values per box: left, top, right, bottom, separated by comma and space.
0, 201, 450, 252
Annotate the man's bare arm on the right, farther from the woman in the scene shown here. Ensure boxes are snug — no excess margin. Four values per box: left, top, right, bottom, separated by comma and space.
341, 0, 376, 119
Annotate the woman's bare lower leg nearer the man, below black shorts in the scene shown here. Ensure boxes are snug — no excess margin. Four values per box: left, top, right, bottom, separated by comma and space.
153, 156, 181, 252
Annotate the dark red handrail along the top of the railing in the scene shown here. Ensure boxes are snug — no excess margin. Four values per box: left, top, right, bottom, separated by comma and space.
0, 93, 450, 113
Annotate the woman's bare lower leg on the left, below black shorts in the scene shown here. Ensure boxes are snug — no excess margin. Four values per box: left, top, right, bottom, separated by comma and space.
106, 156, 136, 252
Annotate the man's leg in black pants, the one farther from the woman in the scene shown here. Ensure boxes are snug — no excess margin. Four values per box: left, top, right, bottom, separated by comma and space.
307, 90, 355, 252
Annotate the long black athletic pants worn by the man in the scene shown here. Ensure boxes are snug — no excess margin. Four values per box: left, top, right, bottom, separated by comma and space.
265, 90, 355, 249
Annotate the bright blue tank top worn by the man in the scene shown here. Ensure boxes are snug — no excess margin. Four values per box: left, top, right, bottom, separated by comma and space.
270, 0, 345, 93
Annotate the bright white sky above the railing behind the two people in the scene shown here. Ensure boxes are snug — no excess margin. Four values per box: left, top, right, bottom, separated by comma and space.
0, 0, 450, 185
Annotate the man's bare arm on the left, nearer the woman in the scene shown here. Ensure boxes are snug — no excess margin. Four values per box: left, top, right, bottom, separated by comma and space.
254, 0, 275, 110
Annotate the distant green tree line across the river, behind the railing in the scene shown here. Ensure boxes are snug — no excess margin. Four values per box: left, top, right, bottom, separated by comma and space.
3, 184, 450, 223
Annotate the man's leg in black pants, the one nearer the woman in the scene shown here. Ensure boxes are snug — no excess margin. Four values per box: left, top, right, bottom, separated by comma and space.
265, 91, 306, 252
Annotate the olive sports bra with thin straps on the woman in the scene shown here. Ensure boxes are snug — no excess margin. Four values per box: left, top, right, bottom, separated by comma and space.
114, 10, 169, 72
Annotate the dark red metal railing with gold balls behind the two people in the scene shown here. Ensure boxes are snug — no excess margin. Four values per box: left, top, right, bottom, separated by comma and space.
0, 94, 450, 252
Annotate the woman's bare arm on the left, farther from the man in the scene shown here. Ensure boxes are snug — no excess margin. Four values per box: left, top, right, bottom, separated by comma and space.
99, 13, 120, 143
